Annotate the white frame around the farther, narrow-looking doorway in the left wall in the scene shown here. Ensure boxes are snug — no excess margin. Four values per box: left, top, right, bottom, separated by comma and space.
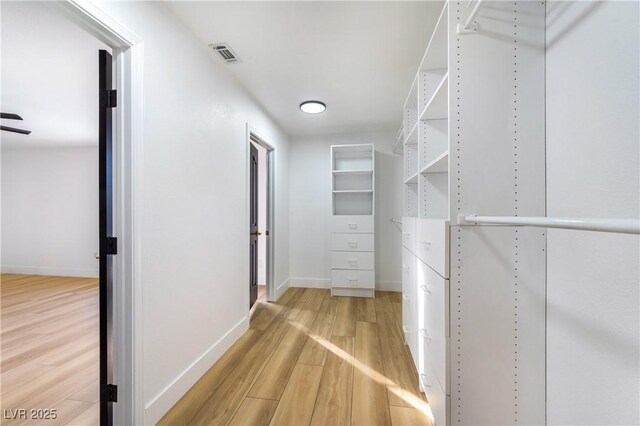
246, 123, 277, 306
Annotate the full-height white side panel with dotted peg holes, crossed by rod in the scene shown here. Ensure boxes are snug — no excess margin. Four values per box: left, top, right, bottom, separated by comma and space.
449, 1, 546, 425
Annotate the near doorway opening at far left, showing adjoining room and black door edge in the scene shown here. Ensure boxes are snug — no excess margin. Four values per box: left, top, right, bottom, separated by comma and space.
0, 2, 117, 425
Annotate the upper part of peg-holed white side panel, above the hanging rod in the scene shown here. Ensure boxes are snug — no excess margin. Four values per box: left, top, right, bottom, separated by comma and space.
449, 1, 545, 217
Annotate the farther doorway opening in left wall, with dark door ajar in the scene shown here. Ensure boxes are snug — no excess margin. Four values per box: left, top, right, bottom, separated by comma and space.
248, 131, 275, 309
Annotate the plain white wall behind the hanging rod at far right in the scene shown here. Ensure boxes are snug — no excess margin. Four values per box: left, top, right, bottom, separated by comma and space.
547, 1, 640, 424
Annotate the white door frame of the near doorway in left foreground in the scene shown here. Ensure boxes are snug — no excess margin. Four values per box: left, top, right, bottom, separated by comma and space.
55, 0, 145, 424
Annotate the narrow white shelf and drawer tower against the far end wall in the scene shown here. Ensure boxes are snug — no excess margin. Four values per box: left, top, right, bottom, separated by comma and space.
331, 144, 375, 297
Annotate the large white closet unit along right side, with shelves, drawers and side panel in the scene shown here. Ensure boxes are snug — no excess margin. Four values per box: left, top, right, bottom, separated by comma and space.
402, 0, 546, 426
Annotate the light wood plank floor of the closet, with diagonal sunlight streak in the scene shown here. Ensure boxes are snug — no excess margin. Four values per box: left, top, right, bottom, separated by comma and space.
159, 288, 431, 426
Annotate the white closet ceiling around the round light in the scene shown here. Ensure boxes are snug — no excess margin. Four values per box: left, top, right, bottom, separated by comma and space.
168, 1, 442, 136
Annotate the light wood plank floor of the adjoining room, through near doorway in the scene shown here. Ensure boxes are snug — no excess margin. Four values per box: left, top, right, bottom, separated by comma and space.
0, 274, 100, 425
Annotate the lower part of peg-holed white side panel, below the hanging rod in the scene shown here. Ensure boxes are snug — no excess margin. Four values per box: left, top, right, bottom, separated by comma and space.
449, 226, 546, 425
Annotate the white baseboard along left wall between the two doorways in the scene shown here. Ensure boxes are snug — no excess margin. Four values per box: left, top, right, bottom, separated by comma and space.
144, 317, 249, 424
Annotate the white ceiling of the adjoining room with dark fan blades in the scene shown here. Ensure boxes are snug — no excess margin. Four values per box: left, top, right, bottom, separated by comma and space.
0, 1, 110, 148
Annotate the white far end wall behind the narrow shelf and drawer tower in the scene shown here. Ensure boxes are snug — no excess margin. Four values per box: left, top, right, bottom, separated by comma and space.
290, 133, 402, 291
